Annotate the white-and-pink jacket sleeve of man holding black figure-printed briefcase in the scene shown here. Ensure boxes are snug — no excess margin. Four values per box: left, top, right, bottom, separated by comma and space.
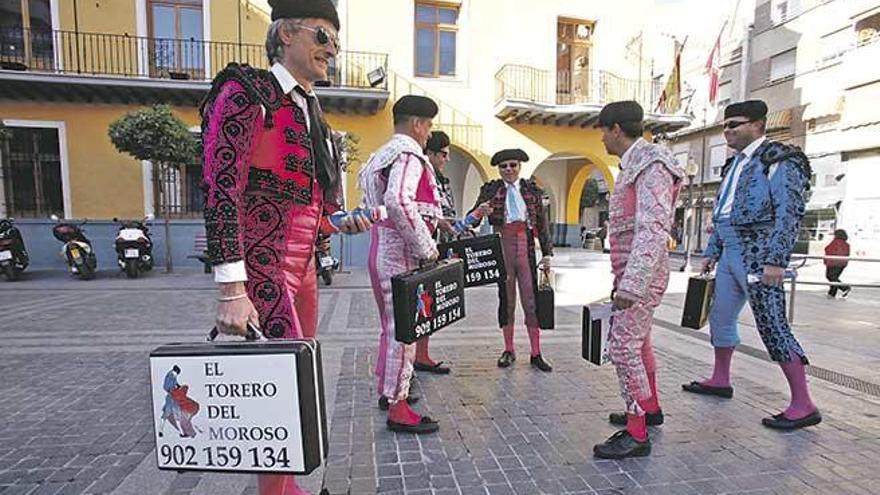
385, 153, 436, 259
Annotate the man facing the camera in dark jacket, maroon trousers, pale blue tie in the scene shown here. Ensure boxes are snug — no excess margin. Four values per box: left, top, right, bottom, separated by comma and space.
471, 149, 553, 372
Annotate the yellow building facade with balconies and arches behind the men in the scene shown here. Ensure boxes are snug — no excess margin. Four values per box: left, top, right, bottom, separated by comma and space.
0, 0, 687, 268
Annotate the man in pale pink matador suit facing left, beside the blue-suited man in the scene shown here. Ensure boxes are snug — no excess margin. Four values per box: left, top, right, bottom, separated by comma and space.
593, 101, 684, 459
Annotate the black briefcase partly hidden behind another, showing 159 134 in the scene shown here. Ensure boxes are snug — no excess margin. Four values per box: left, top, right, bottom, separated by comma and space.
437, 234, 507, 287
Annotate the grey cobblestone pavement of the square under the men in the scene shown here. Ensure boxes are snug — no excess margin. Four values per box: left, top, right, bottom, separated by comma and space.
0, 252, 880, 495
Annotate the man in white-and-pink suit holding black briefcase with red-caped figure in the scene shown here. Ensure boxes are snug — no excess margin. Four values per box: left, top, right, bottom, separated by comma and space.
359, 95, 442, 433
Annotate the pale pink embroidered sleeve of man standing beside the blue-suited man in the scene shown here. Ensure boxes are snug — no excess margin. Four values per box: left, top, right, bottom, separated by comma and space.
617, 163, 675, 298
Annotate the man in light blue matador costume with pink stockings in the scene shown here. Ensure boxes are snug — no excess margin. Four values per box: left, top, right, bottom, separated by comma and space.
682, 100, 822, 430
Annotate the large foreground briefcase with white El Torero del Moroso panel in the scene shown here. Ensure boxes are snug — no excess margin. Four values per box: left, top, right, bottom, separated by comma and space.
150, 339, 328, 474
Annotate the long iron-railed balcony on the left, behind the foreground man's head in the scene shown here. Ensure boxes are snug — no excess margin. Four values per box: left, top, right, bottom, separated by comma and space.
0, 27, 388, 111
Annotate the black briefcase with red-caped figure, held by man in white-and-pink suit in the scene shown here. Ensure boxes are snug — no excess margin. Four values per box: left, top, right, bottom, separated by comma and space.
391, 259, 464, 344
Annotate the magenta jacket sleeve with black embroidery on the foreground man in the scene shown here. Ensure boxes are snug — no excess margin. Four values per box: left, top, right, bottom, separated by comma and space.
202, 80, 263, 265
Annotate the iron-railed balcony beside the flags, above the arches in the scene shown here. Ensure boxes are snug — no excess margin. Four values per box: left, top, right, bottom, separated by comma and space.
495, 64, 689, 132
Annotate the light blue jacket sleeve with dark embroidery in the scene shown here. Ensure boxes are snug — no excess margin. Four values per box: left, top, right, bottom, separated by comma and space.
764, 160, 807, 267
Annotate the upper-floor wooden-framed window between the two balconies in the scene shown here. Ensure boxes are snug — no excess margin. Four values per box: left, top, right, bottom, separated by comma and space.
415, 1, 458, 77
